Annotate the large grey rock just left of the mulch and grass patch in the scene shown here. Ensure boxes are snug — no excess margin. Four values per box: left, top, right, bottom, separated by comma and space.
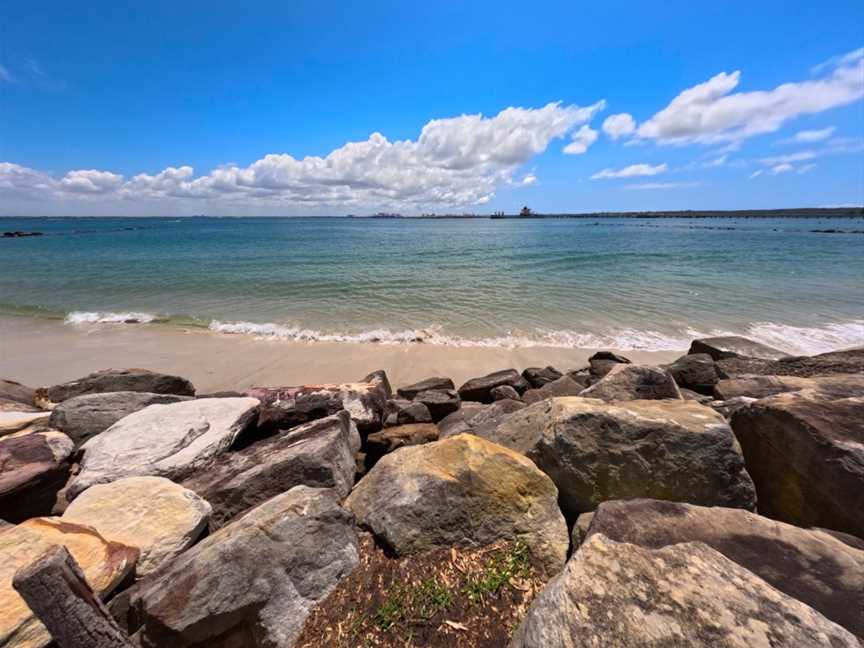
127, 486, 358, 648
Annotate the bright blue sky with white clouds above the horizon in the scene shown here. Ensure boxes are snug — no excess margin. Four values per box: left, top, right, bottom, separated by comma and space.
0, 0, 864, 216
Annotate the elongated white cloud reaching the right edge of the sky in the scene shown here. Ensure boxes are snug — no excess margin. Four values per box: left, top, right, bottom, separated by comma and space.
636, 48, 864, 144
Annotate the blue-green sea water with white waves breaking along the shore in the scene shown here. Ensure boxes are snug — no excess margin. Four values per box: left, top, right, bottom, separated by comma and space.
0, 218, 864, 353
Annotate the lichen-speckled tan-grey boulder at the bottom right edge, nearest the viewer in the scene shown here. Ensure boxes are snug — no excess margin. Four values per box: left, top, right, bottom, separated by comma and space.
510, 534, 859, 648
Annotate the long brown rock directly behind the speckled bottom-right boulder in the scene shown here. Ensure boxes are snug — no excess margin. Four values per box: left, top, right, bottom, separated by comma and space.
579, 499, 864, 637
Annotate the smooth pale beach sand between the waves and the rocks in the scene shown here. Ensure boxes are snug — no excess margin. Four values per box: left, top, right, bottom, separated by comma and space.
0, 317, 685, 393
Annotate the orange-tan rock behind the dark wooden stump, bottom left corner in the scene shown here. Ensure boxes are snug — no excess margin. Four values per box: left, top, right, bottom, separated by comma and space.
0, 518, 138, 648
